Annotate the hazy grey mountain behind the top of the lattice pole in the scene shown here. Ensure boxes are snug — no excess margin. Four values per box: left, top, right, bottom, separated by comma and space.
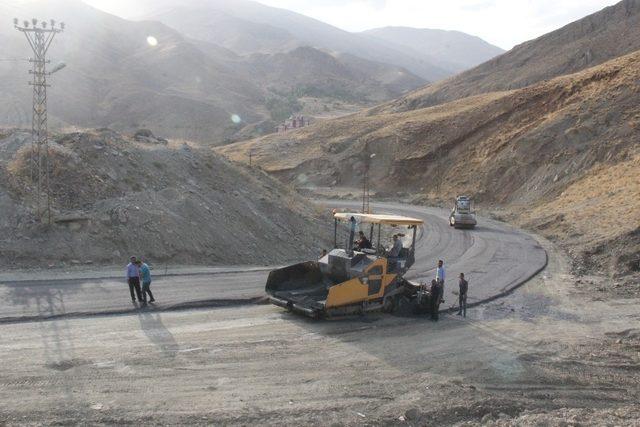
0, 0, 263, 144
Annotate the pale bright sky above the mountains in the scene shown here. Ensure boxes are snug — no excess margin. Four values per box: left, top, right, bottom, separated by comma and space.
85, 0, 617, 49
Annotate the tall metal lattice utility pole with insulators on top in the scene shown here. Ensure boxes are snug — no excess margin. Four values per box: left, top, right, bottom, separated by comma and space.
13, 18, 64, 224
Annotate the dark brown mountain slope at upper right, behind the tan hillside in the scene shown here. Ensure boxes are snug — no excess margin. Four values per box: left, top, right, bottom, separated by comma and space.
381, 0, 640, 111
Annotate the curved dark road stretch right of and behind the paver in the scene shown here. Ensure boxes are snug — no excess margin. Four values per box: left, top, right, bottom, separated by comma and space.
331, 201, 547, 307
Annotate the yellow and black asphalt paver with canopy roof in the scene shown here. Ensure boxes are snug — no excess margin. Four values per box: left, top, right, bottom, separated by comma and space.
266, 212, 423, 318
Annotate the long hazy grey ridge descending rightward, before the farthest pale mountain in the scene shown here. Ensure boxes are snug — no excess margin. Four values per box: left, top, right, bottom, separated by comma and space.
138, 0, 502, 81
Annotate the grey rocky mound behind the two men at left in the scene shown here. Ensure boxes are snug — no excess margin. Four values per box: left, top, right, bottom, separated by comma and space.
0, 129, 330, 268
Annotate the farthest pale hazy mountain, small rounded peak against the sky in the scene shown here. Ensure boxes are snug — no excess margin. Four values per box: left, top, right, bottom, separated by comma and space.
361, 27, 504, 73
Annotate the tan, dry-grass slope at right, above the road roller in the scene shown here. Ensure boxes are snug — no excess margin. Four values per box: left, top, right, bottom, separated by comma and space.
221, 52, 640, 282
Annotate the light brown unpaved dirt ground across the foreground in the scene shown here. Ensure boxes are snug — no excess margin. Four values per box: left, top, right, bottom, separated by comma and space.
0, 203, 640, 426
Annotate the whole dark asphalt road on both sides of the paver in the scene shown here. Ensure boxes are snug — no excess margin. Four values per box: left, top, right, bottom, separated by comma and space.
0, 201, 546, 323
